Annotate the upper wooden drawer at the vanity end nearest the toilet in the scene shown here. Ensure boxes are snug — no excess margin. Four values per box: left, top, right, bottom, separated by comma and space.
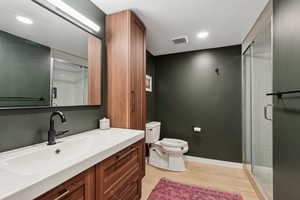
103, 145, 140, 191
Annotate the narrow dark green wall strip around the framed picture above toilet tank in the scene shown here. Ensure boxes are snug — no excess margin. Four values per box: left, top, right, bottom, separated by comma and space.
146, 52, 156, 122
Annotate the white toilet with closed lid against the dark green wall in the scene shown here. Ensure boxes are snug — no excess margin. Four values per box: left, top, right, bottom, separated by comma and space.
146, 122, 189, 171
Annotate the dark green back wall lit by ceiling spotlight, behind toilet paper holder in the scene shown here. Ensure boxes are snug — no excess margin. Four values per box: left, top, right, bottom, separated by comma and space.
155, 46, 242, 162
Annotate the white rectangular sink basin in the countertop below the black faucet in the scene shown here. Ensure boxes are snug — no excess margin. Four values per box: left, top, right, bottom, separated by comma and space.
0, 138, 92, 175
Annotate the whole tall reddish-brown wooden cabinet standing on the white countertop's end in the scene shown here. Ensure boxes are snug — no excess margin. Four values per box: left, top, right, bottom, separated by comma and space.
106, 10, 146, 130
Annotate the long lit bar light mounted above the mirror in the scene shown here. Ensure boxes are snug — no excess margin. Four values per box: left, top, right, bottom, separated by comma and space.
46, 0, 100, 32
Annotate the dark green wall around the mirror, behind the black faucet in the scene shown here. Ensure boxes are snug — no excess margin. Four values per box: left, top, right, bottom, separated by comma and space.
0, 0, 106, 152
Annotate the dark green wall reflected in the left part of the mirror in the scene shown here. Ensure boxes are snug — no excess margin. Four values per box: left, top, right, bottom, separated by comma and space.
0, 31, 50, 107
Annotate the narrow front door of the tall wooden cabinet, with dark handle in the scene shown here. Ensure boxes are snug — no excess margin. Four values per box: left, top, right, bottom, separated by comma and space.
130, 13, 146, 130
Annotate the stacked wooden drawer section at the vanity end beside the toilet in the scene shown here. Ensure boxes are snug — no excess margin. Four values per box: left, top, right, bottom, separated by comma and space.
96, 140, 145, 200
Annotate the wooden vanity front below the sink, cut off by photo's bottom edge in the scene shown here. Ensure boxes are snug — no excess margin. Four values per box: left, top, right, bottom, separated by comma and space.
36, 167, 95, 200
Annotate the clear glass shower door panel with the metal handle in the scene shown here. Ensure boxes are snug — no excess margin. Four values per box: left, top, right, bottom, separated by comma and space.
251, 19, 273, 200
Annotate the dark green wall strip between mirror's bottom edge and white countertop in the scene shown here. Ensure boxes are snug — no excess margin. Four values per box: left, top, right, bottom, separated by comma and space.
0, 107, 104, 152
